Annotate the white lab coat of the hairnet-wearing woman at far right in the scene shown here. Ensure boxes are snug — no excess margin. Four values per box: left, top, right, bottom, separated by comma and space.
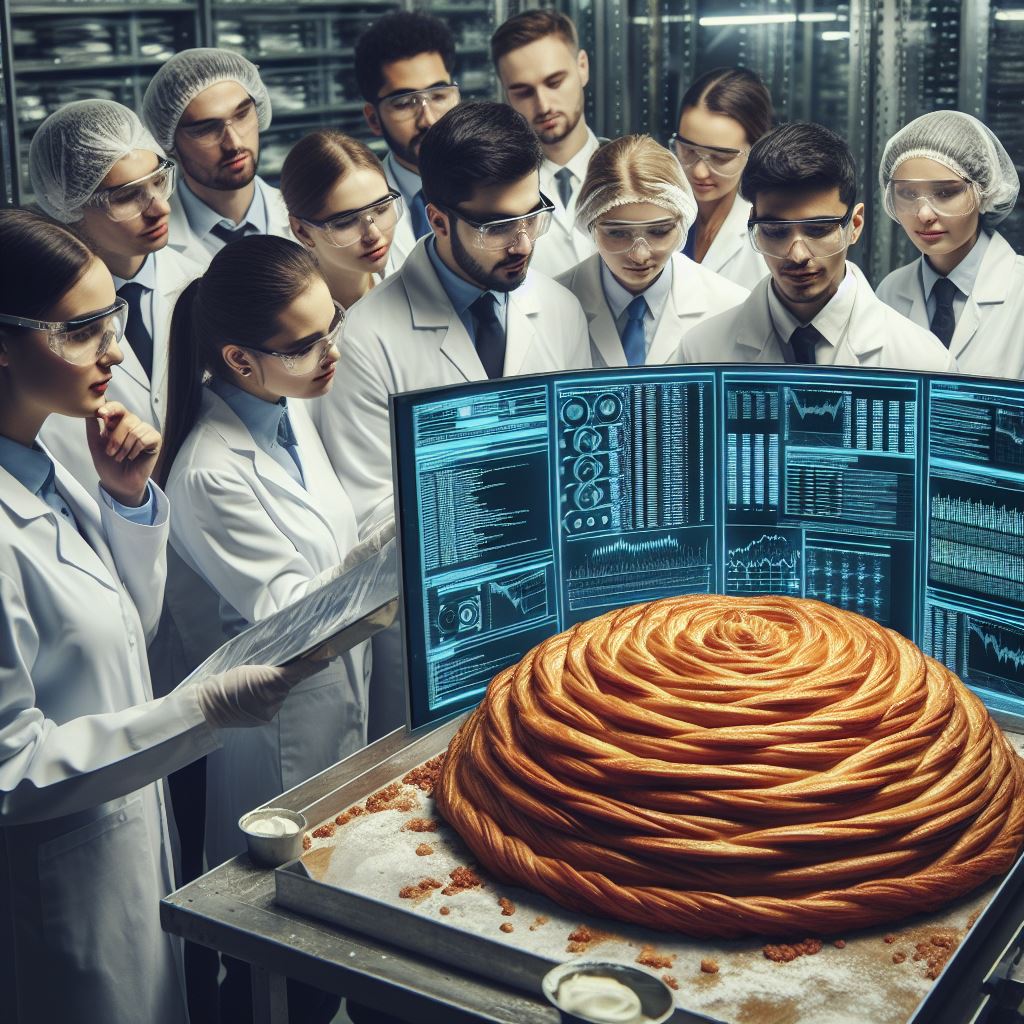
878, 231, 1024, 379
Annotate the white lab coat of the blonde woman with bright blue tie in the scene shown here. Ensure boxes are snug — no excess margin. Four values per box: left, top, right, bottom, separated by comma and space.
556, 253, 748, 367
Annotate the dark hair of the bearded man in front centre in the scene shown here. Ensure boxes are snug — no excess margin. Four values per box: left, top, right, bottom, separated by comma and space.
419, 101, 544, 208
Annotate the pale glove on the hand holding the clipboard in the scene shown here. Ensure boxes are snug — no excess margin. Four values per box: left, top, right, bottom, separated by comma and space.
196, 660, 315, 729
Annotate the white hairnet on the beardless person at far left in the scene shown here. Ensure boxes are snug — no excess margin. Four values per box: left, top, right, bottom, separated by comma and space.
29, 99, 165, 224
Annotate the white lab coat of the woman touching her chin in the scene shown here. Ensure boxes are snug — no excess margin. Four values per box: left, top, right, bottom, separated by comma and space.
0, 454, 217, 1024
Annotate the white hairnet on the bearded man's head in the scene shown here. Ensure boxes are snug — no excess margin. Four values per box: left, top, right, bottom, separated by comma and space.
142, 47, 270, 153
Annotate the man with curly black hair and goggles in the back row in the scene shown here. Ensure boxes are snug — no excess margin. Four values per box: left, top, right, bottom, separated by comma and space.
355, 10, 461, 267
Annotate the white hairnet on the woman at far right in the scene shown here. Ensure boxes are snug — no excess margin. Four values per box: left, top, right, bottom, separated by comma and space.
879, 111, 1020, 227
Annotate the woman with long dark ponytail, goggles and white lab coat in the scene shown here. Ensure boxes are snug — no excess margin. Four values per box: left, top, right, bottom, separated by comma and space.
160, 236, 393, 1021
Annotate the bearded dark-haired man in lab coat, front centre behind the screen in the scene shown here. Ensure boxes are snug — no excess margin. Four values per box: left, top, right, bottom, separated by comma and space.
316, 102, 591, 531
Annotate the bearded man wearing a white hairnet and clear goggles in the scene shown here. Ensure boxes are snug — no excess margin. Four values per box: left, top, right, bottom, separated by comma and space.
142, 47, 292, 267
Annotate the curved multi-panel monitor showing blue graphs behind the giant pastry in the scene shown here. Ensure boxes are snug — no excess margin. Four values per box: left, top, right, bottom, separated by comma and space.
392, 365, 1024, 726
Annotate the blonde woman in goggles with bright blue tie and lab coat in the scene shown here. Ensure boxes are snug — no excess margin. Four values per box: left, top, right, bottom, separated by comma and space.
557, 135, 748, 367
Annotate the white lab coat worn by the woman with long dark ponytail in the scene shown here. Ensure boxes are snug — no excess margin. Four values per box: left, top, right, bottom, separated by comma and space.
167, 389, 370, 866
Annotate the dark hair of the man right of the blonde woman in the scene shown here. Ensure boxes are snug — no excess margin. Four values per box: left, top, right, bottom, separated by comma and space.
739, 121, 857, 215
